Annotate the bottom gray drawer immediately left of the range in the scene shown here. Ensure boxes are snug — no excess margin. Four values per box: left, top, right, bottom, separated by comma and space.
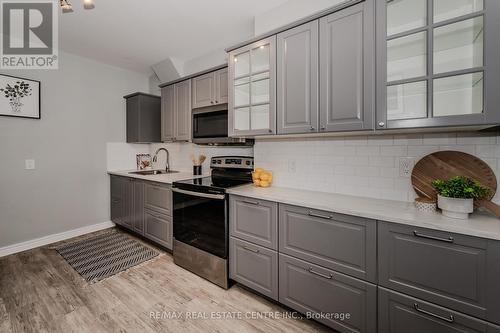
144, 209, 173, 250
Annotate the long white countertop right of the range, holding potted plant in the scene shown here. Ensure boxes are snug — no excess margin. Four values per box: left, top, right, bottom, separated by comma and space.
228, 185, 500, 240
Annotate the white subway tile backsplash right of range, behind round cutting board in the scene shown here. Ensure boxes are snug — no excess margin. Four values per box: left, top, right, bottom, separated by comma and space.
254, 133, 500, 203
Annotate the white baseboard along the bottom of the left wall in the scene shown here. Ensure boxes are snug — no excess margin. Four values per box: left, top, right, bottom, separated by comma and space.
0, 221, 115, 258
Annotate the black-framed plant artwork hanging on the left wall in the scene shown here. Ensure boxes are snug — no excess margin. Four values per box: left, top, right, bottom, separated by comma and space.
0, 74, 40, 119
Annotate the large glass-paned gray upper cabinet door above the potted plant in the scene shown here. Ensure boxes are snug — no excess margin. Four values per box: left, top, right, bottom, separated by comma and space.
377, 0, 500, 129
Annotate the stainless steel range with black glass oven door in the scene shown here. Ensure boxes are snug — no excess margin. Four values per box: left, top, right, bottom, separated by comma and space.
172, 156, 253, 289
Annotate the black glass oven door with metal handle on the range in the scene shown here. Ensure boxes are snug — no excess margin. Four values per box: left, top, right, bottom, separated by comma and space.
172, 188, 228, 259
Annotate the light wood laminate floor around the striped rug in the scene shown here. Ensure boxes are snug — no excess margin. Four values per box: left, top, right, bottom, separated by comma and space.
0, 228, 329, 333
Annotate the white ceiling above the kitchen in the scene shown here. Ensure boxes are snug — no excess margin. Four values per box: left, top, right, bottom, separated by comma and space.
59, 0, 287, 72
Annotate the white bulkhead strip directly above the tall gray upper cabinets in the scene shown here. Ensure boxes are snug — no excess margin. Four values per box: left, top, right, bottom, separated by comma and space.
254, 0, 346, 36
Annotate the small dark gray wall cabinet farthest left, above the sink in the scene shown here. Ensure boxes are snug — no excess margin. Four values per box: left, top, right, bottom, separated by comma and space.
124, 93, 161, 143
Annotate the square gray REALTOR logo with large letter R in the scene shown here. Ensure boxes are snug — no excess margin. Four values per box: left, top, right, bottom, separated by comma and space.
0, 0, 58, 69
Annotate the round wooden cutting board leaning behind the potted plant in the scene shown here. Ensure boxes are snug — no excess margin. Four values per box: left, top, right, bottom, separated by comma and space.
411, 151, 497, 200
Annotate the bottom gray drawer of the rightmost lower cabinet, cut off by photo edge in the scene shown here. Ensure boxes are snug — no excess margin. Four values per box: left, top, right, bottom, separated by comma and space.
378, 288, 500, 333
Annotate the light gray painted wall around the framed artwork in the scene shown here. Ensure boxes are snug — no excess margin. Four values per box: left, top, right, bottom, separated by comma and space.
0, 52, 149, 247
